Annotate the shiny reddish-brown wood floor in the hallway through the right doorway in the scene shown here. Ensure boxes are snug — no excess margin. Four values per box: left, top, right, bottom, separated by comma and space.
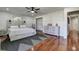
67, 30, 79, 51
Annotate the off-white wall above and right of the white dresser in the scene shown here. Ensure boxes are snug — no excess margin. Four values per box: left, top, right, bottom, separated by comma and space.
37, 10, 67, 38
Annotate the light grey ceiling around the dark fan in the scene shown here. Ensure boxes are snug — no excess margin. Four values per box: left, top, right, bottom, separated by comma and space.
0, 7, 64, 16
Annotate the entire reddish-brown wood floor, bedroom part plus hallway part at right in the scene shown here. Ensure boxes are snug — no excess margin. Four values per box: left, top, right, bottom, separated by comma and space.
2, 31, 79, 51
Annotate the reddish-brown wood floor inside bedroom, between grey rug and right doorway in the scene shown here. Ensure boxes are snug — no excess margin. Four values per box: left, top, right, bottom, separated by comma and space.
29, 36, 67, 51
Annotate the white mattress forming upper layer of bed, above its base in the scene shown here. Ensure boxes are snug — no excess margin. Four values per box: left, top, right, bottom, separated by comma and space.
9, 28, 36, 35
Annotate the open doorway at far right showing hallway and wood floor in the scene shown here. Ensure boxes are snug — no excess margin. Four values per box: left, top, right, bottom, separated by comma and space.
68, 14, 79, 51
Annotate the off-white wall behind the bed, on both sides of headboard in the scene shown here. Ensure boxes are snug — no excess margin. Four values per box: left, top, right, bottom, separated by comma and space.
0, 12, 33, 30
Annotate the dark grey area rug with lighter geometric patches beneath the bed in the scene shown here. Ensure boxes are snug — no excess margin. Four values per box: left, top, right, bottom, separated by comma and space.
1, 35, 48, 51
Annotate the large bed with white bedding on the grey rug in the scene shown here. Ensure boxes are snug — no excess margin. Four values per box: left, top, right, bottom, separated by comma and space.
8, 27, 36, 41
